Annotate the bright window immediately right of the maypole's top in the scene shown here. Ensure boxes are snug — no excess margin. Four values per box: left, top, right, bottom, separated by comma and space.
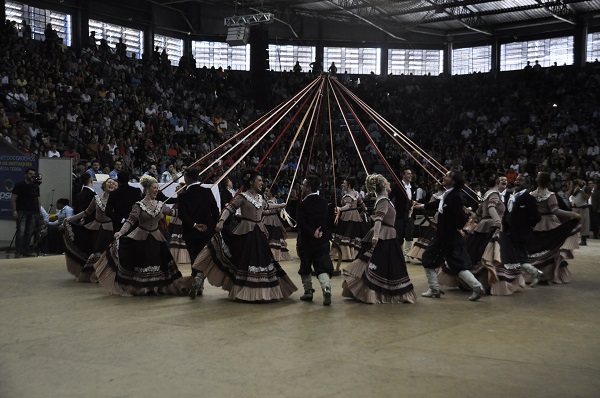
323, 47, 381, 75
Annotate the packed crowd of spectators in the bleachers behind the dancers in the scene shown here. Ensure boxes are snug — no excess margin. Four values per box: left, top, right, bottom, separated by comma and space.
0, 17, 600, 205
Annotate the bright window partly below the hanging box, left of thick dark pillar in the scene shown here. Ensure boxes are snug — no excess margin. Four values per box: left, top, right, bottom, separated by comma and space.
192, 41, 250, 70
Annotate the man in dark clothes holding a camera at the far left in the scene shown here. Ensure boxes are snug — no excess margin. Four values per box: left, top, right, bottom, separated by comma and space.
10, 168, 41, 258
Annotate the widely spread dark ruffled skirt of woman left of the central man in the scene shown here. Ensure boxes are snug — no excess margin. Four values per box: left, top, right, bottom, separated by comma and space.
192, 228, 298, 302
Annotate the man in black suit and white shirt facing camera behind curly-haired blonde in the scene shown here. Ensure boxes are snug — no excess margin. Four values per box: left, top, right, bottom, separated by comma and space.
389, 168, 417, 263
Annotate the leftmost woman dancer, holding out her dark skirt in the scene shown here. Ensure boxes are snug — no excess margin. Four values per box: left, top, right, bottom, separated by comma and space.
63, 178, 118, 282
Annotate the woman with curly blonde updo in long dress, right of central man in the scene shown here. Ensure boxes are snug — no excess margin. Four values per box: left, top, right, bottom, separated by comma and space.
342, 174, 417, 304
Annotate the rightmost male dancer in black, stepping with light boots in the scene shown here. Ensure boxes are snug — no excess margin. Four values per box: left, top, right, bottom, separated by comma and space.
504, 174, 544, 287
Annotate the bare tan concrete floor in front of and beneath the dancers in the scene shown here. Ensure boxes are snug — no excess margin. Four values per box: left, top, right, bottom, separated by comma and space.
0, 240, 600, 398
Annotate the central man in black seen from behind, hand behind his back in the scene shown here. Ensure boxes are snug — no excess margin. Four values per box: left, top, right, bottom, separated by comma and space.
296, 176, 333, 305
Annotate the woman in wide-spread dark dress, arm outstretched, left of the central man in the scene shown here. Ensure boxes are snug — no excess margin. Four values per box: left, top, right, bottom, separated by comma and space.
192, 169, 298, 302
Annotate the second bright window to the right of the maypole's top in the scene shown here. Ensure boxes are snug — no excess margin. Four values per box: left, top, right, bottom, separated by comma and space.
388, 49, 444, 76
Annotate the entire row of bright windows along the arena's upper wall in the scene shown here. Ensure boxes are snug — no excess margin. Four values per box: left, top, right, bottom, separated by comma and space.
5, 1, 600, 75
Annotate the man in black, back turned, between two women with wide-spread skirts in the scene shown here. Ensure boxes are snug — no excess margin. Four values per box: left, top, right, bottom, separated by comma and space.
177, 167, 220, 299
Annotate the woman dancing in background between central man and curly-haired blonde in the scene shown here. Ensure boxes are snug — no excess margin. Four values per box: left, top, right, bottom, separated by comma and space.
331, 177, 370, 264
